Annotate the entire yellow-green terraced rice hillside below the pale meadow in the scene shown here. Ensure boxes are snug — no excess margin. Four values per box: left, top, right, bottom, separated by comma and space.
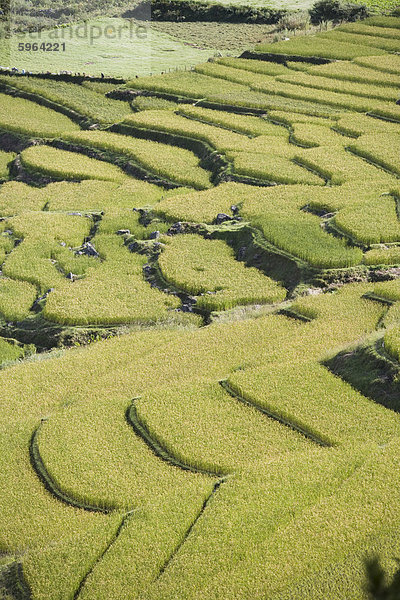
0, 18, 400, 600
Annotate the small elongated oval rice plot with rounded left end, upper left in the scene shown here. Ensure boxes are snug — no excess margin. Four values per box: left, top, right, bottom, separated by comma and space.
21, 146, 126, 182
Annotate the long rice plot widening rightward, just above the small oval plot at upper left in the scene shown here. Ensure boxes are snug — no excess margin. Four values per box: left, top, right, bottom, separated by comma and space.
62, 130, 211, 189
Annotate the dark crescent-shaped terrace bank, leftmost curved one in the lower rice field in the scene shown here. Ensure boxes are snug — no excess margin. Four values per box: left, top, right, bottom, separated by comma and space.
29, 421, 113, 514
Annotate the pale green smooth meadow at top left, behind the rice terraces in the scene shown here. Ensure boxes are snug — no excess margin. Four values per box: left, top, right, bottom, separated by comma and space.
0, 18, 222, 77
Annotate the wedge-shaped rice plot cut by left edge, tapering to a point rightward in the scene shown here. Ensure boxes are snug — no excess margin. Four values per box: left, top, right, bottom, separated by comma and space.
0, 94, 79, 138
